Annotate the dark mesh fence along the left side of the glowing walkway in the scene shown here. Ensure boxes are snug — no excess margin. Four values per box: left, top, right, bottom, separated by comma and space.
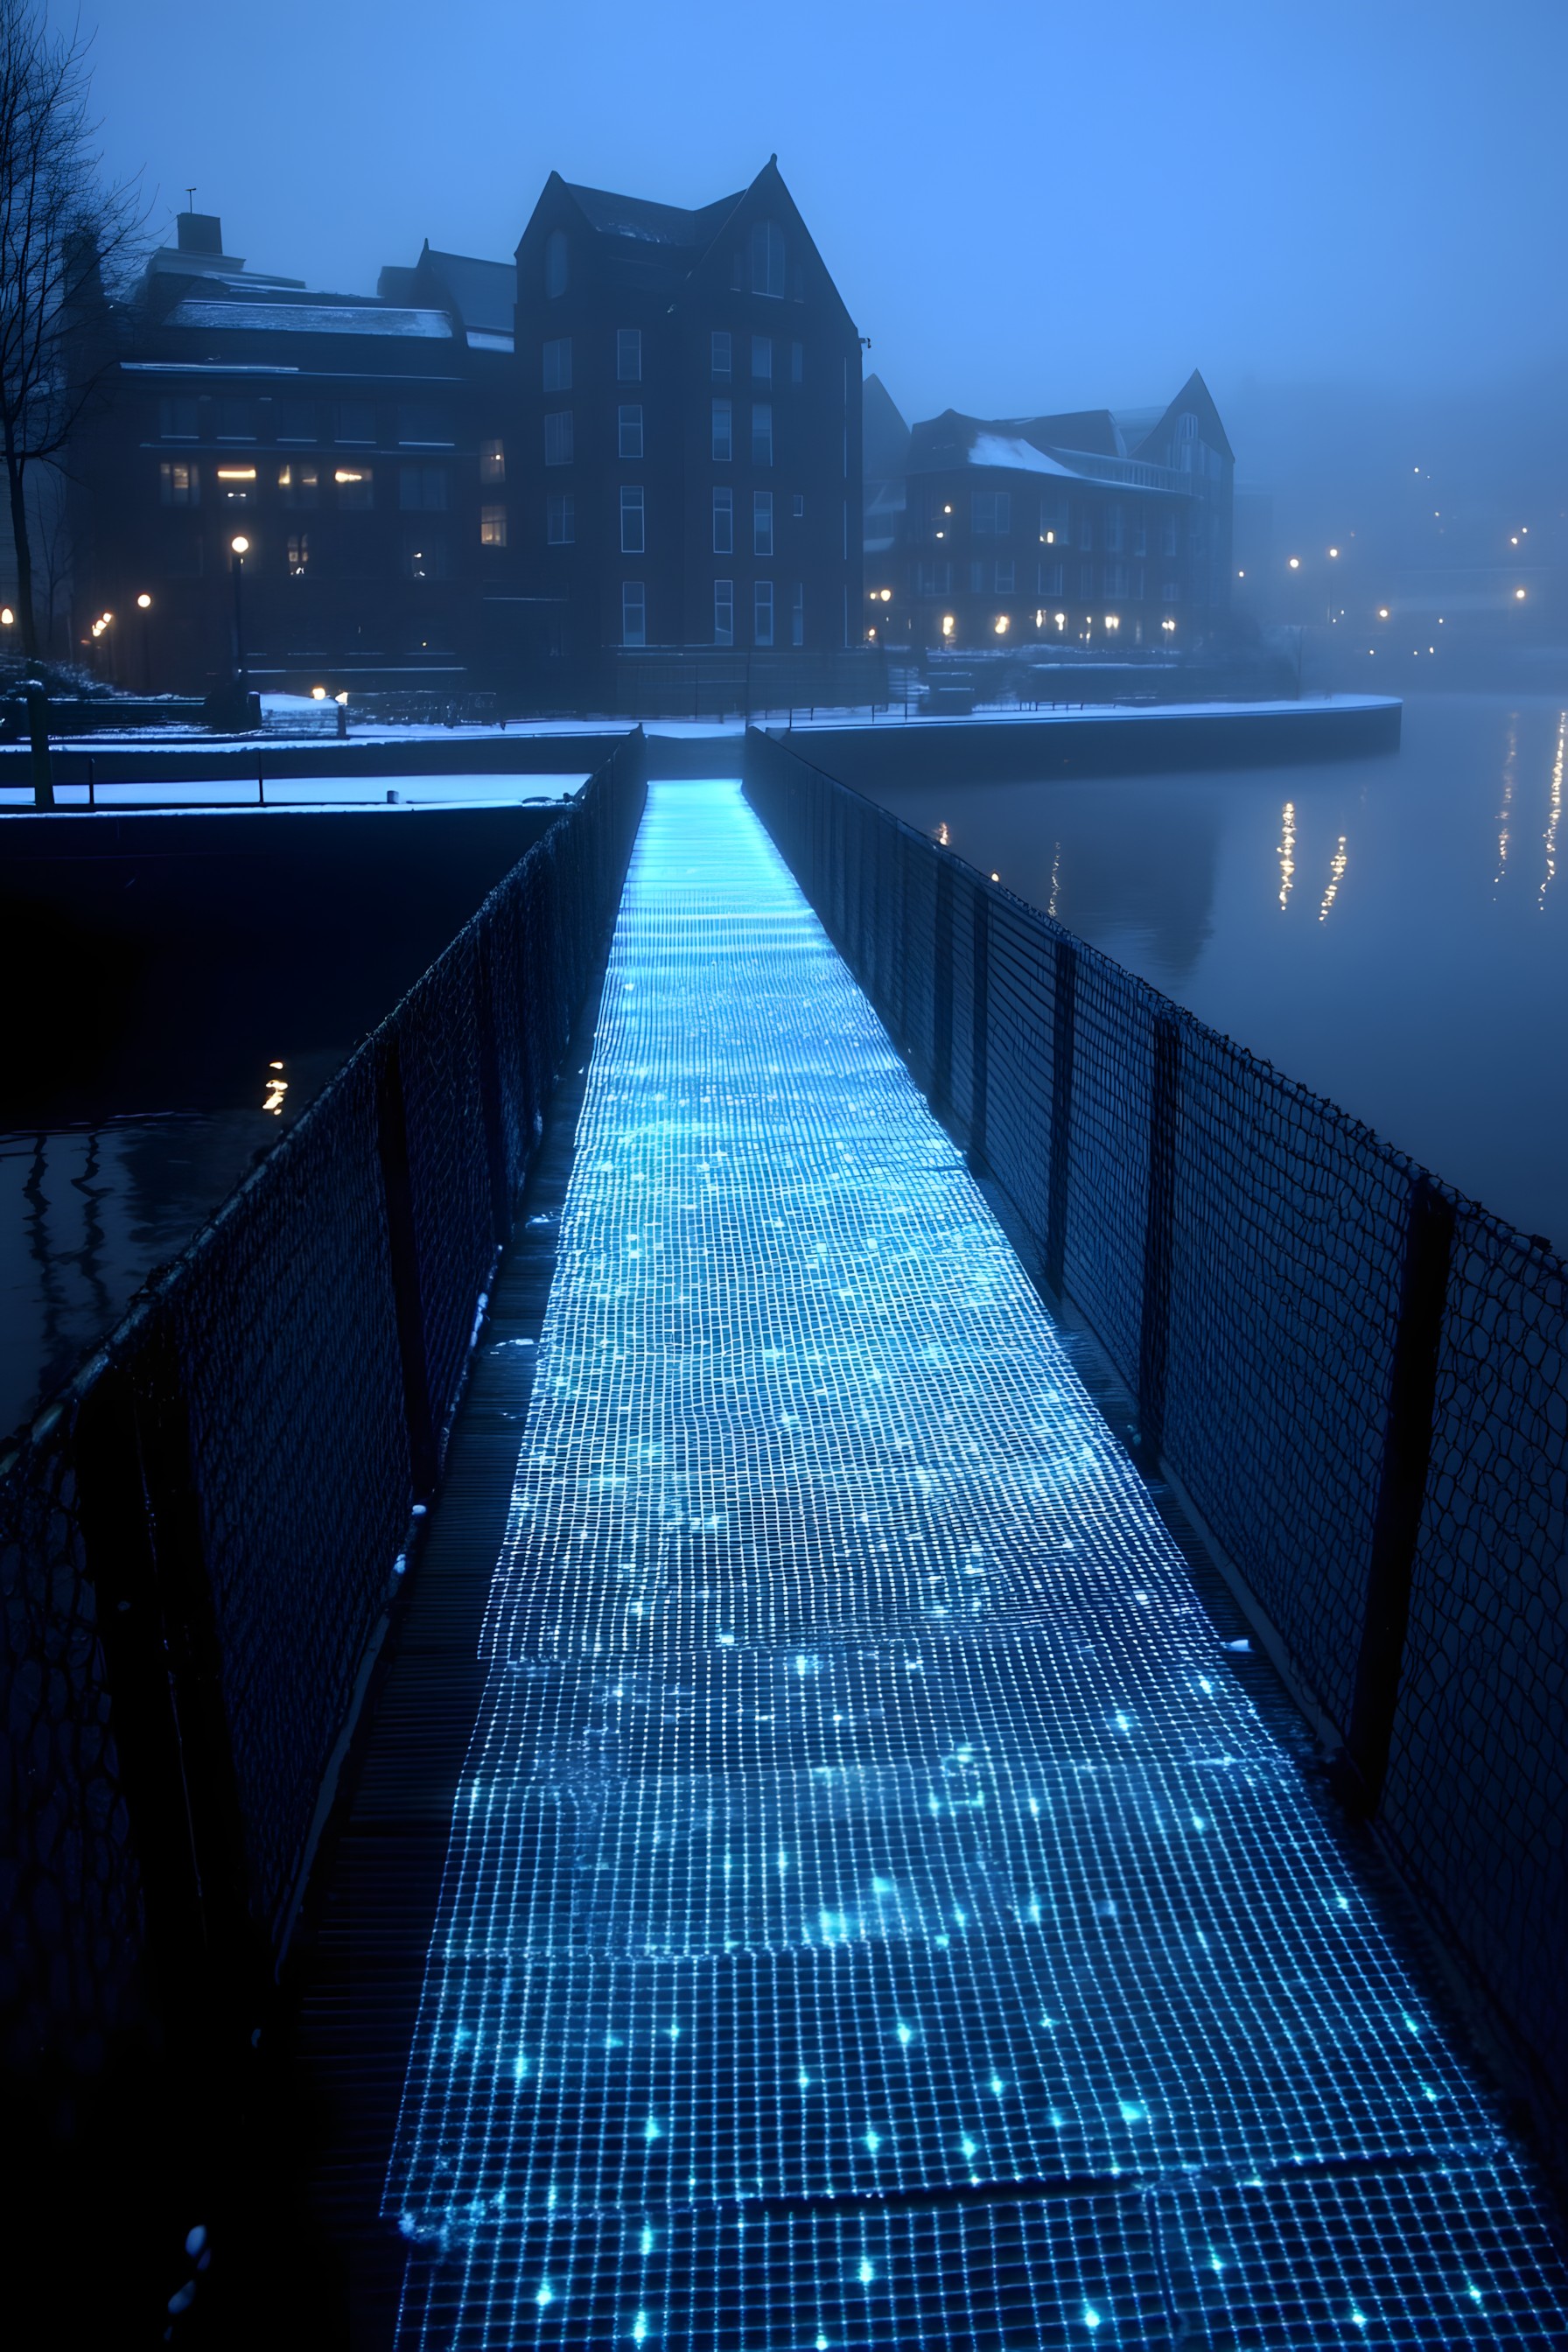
0, 734, 647, 2107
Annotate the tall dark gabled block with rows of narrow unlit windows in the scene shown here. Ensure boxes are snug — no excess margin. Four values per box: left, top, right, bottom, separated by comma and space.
514, 160, 860, 682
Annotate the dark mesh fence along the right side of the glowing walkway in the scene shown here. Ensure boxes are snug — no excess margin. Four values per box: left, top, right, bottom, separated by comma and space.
746, 729, 1568, 2164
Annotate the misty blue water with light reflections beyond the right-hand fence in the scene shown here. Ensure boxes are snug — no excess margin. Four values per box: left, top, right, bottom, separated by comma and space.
884, 696, 1568, 1249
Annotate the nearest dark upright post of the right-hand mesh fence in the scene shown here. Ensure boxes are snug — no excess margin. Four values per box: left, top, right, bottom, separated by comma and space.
1345, 1176, 1452, 1816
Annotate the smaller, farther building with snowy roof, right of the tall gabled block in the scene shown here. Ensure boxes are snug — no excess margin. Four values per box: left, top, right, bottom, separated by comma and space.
865, 374, 1234, 652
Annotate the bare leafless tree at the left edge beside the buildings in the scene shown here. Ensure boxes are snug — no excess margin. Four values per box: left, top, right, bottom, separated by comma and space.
0, 0, 141, 659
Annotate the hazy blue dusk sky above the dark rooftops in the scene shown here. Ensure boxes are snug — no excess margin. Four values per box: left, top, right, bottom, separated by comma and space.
76, 0, 1568, 437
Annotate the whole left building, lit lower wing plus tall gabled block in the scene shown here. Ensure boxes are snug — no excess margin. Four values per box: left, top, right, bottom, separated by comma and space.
71, 160, 863, 705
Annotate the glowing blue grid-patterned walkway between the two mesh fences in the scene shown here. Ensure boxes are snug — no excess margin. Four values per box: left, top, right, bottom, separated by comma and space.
388, 783, 1568, 2352
